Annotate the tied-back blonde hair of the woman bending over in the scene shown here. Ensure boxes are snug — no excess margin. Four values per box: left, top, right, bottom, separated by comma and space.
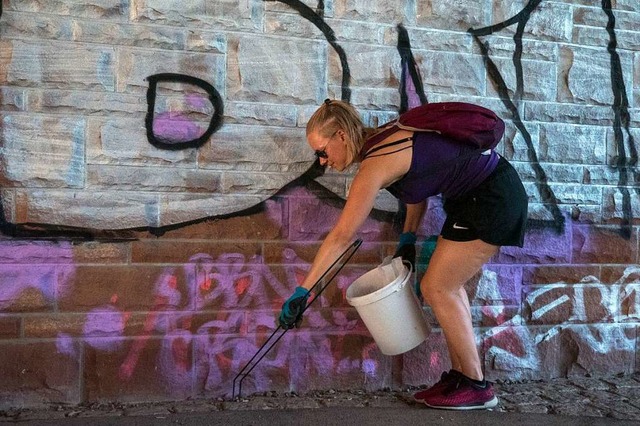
307, 99, 370, 165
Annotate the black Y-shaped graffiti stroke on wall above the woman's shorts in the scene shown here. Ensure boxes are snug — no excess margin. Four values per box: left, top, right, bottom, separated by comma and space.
468, 0, 565, 234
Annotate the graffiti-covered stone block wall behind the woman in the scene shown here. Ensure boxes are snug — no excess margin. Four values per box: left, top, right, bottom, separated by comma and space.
0, 0, 640, 407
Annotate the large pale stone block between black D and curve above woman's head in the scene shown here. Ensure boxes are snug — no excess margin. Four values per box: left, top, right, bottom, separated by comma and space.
228, 35, 326, 105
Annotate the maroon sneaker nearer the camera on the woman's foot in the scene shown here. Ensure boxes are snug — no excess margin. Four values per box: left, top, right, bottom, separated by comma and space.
422, 374, 498, 410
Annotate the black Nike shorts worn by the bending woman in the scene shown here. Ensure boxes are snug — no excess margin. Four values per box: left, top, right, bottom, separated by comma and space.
440, 157, 528, 247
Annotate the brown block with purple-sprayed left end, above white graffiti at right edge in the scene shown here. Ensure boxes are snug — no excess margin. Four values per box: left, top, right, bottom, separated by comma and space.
572, 226, 638, 264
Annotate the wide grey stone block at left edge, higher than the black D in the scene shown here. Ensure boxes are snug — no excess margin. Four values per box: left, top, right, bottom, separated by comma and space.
0, 40, 116, 91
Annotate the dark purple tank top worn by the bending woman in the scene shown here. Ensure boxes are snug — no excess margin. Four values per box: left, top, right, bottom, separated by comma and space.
362, 132, 499, 204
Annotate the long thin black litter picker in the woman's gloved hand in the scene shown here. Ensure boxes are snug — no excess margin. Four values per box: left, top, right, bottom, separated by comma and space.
232, 239, 362, 399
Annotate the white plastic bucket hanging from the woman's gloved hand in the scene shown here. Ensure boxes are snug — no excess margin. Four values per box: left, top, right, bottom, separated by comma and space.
347, 257, 430, 355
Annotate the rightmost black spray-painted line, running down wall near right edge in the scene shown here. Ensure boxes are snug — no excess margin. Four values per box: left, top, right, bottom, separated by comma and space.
602, 0, 640, 239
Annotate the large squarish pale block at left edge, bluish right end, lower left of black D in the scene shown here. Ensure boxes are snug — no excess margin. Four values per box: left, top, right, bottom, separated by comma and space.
0, 115, 86, 188
